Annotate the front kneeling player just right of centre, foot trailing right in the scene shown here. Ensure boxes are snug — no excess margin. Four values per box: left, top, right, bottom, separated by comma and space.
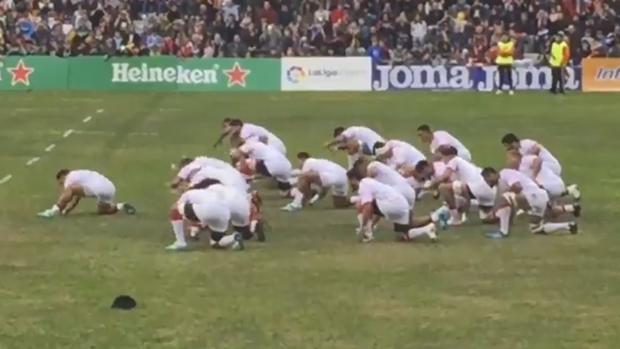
357, 178, 448, 242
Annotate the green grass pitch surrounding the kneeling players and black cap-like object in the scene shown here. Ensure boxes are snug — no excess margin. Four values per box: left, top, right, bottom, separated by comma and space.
0, 93, 620, 349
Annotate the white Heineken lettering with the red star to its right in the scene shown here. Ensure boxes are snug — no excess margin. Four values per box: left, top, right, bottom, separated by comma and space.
112, 62, 251, 87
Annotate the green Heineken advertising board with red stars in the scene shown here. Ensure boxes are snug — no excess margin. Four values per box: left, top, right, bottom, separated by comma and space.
0, 56, 280, 91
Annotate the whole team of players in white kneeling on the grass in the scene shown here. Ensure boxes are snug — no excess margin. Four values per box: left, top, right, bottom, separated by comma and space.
39, 119, 581, 251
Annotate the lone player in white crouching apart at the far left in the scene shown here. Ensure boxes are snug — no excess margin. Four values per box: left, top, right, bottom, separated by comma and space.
38, 169, 136, 218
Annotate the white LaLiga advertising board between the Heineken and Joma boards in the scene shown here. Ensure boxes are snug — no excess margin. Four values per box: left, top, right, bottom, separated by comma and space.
280, 57, 372, 91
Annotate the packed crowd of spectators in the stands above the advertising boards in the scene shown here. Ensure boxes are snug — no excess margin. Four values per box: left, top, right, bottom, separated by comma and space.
0, 0, 620, 64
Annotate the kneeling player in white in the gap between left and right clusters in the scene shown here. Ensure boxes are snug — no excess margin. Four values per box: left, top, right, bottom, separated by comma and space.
282, 152, 351, 211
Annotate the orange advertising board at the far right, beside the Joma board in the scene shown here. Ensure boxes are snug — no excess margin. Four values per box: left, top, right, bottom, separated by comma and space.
583, 58, 620, 92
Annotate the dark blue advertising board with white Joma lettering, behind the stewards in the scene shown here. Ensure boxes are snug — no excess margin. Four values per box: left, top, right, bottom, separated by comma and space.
372, 65, 581, 91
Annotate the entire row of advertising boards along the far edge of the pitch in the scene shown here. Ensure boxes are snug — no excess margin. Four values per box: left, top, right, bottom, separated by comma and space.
0, 56, 620, 91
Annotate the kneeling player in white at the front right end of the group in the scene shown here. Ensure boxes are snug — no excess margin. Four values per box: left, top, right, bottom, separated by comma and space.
482, 167, 580, 239
